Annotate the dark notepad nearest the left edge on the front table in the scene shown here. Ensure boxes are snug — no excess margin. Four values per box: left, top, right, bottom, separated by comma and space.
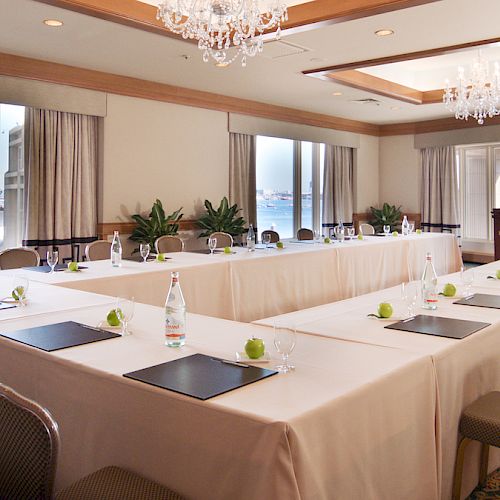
0, 321, 120, 352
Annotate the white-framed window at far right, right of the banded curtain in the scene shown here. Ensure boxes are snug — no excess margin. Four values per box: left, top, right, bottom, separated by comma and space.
457, 145, 500, 240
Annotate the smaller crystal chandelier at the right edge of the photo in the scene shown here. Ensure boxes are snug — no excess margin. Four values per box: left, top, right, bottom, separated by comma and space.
443, 51, 500, 125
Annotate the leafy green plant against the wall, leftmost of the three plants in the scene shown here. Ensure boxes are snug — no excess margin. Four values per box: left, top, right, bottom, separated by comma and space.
129, 199, 183, 253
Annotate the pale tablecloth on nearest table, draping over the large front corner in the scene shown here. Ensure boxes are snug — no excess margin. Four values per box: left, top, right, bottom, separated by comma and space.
0, 305, 438, 500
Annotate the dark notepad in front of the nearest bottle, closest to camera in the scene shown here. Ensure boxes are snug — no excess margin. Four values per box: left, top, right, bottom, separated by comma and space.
123, 354, 278, 400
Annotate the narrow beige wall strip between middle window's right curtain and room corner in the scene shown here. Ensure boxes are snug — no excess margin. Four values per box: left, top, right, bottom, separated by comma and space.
354, 135, 379, 212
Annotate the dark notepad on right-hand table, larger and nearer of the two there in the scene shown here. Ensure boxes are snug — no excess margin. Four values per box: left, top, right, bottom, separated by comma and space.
385, 314, 490, 339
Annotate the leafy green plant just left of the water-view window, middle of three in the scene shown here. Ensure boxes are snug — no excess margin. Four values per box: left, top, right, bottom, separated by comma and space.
197, 196, 246, 238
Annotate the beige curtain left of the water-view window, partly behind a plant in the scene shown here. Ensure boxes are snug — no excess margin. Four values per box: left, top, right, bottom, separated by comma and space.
229, 133, 257, 228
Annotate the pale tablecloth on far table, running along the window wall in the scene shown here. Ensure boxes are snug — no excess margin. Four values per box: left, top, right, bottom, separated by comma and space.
7, 233, 461, 322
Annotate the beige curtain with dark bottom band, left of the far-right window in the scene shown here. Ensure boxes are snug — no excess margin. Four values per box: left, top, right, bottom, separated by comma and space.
420, 146, 460, 235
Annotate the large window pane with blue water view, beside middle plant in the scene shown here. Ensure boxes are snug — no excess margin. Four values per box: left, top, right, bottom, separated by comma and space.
256, 136, 294, 238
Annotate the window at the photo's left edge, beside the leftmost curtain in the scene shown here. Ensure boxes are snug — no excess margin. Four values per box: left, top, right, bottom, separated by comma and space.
0, 104, 24, 248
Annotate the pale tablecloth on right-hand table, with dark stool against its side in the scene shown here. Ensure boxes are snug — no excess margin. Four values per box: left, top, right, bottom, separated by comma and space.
257, 262, 500, 499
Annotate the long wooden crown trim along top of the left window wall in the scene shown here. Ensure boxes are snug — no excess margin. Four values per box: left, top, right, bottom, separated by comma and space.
0, 53, 379, 136
